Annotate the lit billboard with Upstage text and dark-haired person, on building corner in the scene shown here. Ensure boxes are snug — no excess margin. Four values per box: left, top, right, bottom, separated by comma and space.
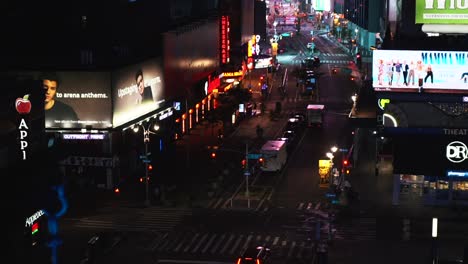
112, 59, 164, 127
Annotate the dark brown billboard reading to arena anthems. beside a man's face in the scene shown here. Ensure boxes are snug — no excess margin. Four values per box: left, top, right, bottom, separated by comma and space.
14, 71, 112, 129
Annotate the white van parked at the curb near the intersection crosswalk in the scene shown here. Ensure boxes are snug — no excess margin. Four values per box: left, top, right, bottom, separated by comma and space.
260, 140, 288, 171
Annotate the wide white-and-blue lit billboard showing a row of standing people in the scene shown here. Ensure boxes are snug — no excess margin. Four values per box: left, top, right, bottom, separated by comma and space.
372, 50, 468, 93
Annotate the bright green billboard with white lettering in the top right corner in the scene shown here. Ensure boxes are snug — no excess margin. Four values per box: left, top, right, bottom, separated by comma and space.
416, 0, 468, 24
